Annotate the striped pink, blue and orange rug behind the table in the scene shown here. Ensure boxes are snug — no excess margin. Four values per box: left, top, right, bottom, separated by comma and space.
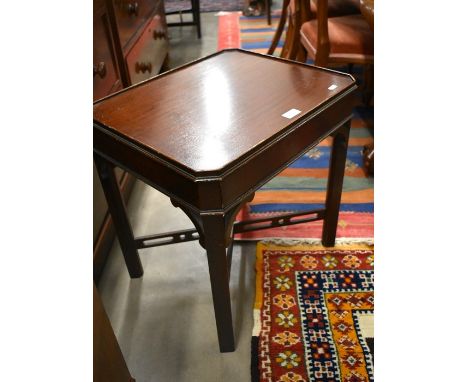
218, 10, 374, 240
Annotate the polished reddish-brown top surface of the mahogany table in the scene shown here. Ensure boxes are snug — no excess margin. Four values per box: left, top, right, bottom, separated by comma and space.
94, 50, 354, 173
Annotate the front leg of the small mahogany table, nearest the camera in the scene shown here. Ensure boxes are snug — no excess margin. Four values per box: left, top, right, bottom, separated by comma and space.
202, 214, 235, 353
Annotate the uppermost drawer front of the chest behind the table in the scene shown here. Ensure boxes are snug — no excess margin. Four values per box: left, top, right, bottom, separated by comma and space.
113, 0, 156, 49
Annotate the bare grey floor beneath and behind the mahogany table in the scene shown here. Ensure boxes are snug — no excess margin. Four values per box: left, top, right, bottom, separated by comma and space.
98, 13, 255, 382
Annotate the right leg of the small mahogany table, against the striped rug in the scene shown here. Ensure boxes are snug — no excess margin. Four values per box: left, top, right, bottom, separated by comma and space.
322, 120, 351, 247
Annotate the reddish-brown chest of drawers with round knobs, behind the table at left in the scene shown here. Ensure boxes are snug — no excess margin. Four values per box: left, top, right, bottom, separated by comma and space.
93, 0, 169, 281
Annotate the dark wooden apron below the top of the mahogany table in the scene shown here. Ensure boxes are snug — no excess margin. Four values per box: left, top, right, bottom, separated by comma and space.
93, 90, 353, 213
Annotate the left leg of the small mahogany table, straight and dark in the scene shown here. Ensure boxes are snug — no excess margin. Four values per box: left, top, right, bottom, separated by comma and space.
94, 154, 143, 278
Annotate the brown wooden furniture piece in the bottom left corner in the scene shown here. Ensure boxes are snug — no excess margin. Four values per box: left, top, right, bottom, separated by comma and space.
93, 284, 135, 382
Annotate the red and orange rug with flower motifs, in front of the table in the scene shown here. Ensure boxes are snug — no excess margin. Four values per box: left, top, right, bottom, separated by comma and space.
252, 241, 374, 382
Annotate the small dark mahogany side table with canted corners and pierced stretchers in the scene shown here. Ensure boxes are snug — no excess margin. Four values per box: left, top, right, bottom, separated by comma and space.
93, 49, 357, 352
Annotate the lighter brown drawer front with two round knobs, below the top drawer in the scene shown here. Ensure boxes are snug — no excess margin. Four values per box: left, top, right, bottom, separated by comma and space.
126, 13, 169, 84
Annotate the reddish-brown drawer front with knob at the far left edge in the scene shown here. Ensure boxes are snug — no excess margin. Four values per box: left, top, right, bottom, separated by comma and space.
93, 1, 122, 100
